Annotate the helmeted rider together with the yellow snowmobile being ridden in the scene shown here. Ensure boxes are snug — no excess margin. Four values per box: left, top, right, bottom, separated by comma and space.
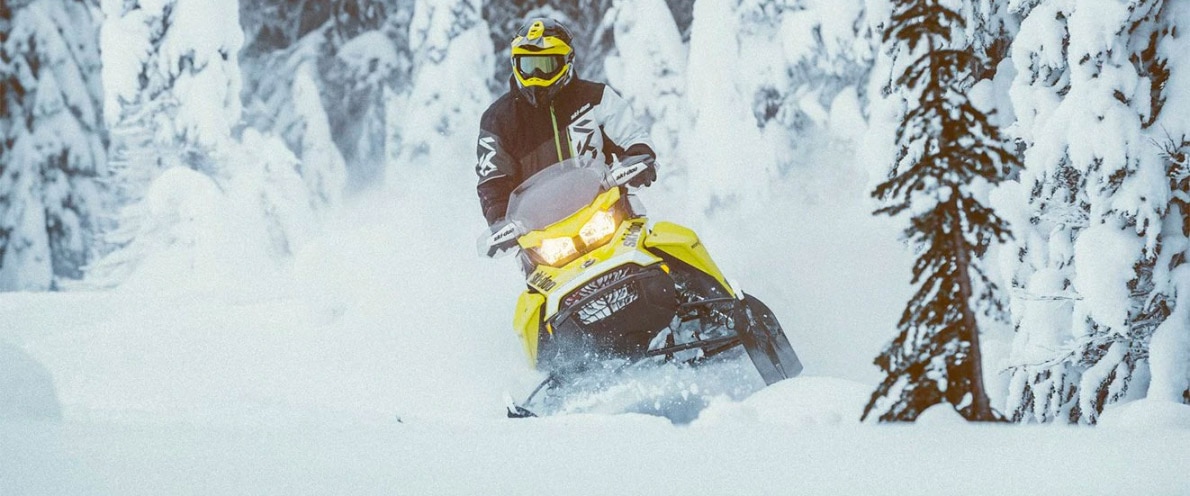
476, 19, 802, 416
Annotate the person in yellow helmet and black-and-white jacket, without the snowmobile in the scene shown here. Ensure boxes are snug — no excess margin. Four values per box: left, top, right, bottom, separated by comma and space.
475, 18, 657, 225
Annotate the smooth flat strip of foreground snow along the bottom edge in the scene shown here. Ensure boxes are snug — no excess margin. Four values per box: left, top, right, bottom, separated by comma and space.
0, 385, 1190, 495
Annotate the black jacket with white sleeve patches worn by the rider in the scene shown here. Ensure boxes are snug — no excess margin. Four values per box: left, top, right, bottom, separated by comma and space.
475, 77, 656, 225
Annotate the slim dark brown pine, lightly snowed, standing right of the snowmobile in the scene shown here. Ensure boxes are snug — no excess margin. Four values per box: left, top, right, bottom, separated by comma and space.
863, 0, 1014, 421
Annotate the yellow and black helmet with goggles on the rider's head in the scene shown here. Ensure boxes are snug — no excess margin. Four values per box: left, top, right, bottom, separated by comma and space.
512, 18, 575, 106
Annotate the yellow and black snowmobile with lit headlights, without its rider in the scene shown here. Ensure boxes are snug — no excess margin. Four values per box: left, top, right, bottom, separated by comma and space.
478, 157, 802, 417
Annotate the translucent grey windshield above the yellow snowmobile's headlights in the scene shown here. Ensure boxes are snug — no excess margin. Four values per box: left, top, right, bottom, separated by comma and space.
507, 157, 607, 231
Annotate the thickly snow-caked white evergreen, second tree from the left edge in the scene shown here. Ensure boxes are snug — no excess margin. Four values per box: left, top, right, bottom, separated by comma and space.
88, 0, 280, 287
